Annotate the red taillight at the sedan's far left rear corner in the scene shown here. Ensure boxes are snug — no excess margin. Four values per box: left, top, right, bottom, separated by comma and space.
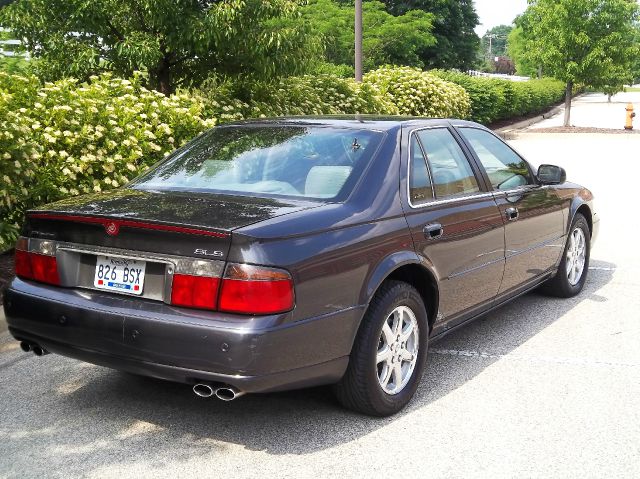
15, 237, 60, 285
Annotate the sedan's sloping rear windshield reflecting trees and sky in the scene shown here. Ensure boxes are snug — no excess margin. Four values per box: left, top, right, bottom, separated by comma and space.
132, 126, 383, 199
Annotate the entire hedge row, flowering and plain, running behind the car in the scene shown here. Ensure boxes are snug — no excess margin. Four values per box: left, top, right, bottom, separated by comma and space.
0, 67, 562, 251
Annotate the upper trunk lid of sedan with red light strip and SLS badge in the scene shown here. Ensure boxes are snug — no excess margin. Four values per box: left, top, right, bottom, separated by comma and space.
25, 189, 315, 259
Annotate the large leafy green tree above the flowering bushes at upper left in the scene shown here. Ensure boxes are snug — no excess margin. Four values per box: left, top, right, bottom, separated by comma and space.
0, 0, 315, 94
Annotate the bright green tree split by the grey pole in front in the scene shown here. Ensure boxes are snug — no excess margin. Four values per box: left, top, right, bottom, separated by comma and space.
302, 0, 436, 70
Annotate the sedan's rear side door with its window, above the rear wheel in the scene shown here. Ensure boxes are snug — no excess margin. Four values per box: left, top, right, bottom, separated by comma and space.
402, 126, 504, 329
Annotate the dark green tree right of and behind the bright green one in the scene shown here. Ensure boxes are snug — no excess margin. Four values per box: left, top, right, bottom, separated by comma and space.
384, 0, 480, 71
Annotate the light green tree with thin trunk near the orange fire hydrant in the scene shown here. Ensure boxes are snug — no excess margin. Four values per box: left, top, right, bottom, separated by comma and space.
522, 0, 640, 126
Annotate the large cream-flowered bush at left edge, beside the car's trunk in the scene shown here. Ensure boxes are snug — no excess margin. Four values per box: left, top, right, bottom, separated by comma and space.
0, 72, 215, 251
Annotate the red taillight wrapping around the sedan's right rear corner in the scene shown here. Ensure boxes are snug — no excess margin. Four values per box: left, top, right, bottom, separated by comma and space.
218, 264, 294, 314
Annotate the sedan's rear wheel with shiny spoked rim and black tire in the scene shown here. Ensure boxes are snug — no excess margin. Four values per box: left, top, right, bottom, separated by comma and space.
335, 281, 429, 416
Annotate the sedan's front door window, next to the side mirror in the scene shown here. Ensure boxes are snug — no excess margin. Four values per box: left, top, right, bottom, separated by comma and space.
459, 128, 533, 190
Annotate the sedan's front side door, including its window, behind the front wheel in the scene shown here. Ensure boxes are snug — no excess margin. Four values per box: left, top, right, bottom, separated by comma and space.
458, 127, 564, 295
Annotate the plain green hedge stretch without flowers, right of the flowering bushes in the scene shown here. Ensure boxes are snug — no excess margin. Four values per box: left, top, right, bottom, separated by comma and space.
431, 70, 565, 125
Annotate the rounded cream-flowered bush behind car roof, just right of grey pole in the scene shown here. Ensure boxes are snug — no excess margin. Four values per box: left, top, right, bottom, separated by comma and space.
364, 67, 471, 118
